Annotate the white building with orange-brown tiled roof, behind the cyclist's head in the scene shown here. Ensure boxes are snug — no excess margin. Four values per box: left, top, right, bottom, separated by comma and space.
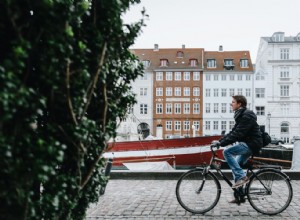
203, 46, 254, 135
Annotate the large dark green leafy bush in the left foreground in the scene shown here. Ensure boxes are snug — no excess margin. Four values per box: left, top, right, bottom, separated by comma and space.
0, 0, 145, 220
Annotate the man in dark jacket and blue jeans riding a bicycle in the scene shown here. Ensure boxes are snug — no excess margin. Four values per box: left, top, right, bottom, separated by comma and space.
213, 95, 263, 203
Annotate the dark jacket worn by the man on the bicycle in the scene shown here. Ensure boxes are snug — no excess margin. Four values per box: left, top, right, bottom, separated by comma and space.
219, 109, 263, 154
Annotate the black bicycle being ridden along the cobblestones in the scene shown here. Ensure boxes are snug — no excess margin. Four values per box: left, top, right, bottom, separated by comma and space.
176, 145, 293, 215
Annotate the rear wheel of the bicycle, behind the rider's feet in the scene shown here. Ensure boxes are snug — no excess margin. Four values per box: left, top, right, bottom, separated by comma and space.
247, 169, 293, 215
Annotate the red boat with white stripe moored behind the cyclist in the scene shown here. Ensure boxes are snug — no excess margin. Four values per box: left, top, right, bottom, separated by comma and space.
104, 136, 223, 169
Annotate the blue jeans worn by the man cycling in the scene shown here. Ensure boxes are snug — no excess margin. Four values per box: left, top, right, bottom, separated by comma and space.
223, 142, 252, 182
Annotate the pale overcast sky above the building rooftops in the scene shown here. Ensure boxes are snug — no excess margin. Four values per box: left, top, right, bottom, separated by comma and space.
124, 0, 300, 63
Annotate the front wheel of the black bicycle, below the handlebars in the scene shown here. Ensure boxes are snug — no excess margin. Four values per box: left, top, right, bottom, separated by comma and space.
176, 169, 221, 214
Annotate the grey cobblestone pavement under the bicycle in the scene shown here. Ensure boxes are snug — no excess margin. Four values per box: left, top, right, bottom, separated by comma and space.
86, 179, 300, 220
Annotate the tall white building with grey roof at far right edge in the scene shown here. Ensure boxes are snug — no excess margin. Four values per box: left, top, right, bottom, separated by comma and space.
254, 32, 300, 142
